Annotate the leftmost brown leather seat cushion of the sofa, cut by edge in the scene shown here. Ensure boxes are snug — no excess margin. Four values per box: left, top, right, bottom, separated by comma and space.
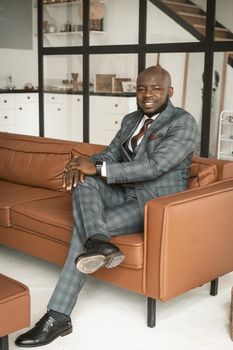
0, 180, 67, 227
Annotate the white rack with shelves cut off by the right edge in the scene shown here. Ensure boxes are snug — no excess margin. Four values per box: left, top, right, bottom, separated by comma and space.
218, 110, 233, 160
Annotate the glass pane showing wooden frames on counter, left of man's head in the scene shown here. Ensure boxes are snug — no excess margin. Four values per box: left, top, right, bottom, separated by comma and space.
89, 54, 138, 145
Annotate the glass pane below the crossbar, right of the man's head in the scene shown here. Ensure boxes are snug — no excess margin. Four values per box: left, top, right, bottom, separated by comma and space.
146, 53, 204, 154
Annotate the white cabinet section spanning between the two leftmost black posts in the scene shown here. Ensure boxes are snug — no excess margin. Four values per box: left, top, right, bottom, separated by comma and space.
44, 93, 83, 142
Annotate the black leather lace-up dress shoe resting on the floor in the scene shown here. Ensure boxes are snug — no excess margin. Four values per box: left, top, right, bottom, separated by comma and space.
15, 312, 72, 348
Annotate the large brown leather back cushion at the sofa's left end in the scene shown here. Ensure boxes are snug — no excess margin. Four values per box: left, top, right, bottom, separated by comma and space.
0, 139, 70, 190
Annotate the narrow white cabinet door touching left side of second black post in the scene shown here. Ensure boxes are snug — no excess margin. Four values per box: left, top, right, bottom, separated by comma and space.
66, 95, 83, 142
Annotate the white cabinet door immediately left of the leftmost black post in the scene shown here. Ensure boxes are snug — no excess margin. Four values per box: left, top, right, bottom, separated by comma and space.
15, 93, 39, 136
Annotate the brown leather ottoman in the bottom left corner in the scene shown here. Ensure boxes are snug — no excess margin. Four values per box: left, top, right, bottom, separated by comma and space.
0, 274, 30, 350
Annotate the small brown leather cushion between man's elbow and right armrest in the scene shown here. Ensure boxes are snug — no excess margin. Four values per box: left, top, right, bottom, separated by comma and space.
189, 158, 218, 188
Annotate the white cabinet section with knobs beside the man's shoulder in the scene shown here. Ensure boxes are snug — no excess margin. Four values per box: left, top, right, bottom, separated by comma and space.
90, 96, 137, 145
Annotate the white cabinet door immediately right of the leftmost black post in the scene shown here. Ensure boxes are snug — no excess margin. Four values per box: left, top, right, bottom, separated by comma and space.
44, 93, 68, 140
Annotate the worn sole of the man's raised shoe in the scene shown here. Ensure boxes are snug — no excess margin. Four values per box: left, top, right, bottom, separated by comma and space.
76, 252, 125, 274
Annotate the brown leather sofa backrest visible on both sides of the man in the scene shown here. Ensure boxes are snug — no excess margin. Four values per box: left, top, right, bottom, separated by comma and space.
0, 132, 233, 191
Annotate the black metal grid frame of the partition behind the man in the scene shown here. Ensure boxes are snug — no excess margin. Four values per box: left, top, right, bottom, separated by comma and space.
37, 0, 233, 157
